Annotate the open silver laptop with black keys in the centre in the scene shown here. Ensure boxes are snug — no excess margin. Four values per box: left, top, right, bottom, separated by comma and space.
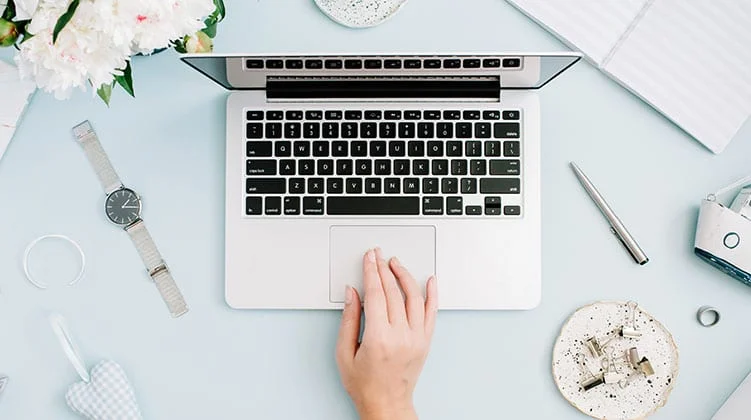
182, 53, 580, 309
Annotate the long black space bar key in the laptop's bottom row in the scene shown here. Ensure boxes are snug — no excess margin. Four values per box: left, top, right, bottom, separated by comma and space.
326, 197, 420, 216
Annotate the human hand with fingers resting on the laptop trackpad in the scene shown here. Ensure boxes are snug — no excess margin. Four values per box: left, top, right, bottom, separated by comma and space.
336, 248, 438, 420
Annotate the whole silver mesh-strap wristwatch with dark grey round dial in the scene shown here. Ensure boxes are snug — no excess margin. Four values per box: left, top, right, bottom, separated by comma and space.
73, 121, 188, 318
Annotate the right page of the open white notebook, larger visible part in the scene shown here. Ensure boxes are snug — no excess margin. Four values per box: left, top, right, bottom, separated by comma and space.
604, 0, 751, 153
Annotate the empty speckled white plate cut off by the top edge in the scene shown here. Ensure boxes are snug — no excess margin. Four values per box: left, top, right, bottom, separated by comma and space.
315, 0, 407, 28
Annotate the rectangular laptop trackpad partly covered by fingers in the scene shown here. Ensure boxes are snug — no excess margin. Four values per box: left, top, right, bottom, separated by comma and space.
329, 226, 435, 303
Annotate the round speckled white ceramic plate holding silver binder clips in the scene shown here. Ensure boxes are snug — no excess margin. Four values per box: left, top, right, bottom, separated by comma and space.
553, 302, 678, 420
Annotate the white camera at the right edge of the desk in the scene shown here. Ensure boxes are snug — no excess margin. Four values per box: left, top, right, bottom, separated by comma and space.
694, 186, 751, 286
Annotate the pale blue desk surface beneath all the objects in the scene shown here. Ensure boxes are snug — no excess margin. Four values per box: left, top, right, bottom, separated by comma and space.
0, 0, 751, 420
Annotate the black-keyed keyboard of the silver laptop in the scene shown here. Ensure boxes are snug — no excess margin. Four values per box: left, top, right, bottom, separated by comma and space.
244, 107, 522, 218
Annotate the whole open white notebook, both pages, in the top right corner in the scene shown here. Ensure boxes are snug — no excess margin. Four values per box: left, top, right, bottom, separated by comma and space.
507, 0, 751, 153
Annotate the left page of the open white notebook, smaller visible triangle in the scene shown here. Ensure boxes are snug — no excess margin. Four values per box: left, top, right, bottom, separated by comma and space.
508, 0, 648, 64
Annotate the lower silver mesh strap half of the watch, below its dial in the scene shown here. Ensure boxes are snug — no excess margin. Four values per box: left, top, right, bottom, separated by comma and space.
125, 220, 188, 318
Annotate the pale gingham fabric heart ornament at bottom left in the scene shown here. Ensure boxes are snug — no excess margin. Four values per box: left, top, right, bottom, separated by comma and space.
65, 360, 143, 420
